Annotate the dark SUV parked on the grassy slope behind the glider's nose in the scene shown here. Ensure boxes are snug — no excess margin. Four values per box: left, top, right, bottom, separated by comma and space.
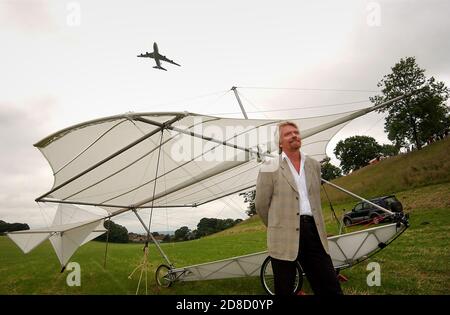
342, 195, 403, 226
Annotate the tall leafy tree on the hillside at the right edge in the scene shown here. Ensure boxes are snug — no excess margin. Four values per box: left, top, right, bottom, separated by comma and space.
370, 57, 450, 150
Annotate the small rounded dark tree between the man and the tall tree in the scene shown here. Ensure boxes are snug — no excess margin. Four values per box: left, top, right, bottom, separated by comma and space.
334, 136, 381, 174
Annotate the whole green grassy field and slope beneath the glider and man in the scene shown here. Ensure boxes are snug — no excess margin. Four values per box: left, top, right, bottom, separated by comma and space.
0, 139, 450, 295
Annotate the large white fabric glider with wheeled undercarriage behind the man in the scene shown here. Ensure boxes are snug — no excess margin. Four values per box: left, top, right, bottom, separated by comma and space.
8, 87, 411, 294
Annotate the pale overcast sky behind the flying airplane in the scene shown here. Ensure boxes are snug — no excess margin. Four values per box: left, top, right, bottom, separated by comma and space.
0, 0, 450, 232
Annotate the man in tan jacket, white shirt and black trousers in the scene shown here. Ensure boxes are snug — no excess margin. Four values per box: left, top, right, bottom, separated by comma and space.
255, 122, 342, 295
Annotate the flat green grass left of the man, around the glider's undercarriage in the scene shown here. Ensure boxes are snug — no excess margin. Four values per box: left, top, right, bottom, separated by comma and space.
0, 225, 266, 294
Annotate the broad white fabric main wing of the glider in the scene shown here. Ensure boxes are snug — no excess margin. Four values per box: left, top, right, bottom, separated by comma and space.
35, 112, 360, 213
